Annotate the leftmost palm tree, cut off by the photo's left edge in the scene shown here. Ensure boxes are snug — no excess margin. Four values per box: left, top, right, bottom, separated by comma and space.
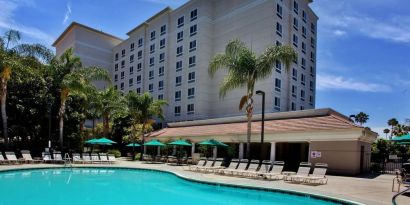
0, 30, 53, 146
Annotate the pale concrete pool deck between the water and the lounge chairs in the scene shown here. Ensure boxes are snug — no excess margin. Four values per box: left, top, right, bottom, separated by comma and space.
0, 161, 410, 205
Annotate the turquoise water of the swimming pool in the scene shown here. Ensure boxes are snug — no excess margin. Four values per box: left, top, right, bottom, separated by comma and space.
0, 168, 350, 205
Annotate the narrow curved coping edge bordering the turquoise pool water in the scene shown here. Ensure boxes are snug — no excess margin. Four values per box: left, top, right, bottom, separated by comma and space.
0, 164, 367, 205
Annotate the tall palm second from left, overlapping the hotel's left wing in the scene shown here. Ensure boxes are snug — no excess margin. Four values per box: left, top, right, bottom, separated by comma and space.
52, 48, 110, 149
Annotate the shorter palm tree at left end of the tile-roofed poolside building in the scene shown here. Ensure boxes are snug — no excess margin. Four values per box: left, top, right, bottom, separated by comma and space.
126, 91, 168, 160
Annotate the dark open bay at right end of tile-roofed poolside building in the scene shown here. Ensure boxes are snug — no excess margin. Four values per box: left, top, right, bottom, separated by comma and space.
275, 142, 309, 171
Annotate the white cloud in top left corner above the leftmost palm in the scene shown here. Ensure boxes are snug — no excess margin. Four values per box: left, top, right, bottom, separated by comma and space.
0, 0, 54, 44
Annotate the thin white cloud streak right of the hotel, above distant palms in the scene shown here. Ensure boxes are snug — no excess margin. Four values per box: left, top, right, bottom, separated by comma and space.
316, 74, 391, 92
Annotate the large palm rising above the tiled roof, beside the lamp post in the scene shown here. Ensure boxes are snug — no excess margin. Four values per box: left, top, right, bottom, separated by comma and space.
208, 39, 297, 158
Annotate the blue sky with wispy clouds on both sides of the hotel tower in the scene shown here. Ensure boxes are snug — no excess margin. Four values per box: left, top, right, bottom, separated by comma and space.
0, 0, 410, 136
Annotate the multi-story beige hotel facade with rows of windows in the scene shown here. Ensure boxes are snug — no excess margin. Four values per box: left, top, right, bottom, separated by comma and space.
53, 0, 318, 122
